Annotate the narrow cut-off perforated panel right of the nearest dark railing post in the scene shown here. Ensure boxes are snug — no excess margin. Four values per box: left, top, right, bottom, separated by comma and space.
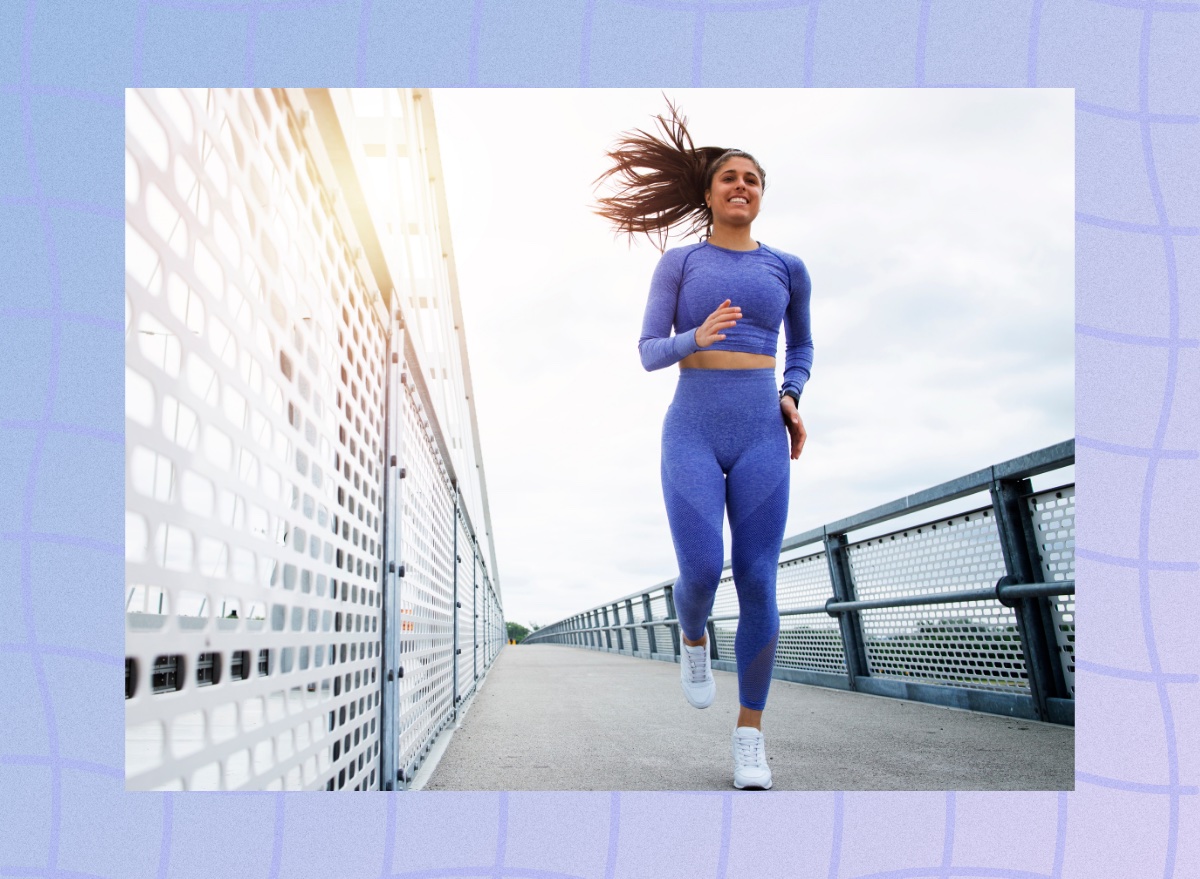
1028, 485, 1075, 696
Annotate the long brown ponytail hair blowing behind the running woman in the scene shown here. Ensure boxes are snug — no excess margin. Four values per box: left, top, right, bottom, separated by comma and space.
595, 100, 767, 251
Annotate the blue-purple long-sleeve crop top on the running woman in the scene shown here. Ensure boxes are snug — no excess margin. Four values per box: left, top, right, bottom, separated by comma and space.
637, 241, 812, 395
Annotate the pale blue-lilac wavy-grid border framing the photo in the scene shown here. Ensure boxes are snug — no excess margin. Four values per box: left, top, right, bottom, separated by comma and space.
0, 0, 1200, 879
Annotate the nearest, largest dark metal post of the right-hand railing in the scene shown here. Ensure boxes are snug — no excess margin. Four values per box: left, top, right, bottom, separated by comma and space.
991, 479, 1067, 720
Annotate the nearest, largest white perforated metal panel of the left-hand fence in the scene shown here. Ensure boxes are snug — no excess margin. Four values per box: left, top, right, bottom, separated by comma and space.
126, 89, 383, 789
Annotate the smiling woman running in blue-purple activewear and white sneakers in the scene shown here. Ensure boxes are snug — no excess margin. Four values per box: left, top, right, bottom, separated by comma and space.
598, 101, 812, 790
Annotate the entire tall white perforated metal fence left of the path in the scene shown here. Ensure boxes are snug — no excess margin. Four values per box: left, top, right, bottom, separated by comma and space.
125, 89, 503, 789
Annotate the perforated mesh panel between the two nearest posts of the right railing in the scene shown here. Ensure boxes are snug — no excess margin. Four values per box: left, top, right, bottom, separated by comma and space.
848, 509, 1028, 692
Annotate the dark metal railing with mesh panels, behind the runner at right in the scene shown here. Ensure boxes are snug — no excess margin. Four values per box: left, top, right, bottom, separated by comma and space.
524, 440, 1075, 724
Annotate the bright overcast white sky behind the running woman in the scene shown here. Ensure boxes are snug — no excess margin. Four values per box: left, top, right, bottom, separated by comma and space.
433, 89, 1074, 624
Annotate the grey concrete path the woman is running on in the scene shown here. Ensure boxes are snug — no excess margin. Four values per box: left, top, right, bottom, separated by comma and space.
425, 645, 1075, 790
